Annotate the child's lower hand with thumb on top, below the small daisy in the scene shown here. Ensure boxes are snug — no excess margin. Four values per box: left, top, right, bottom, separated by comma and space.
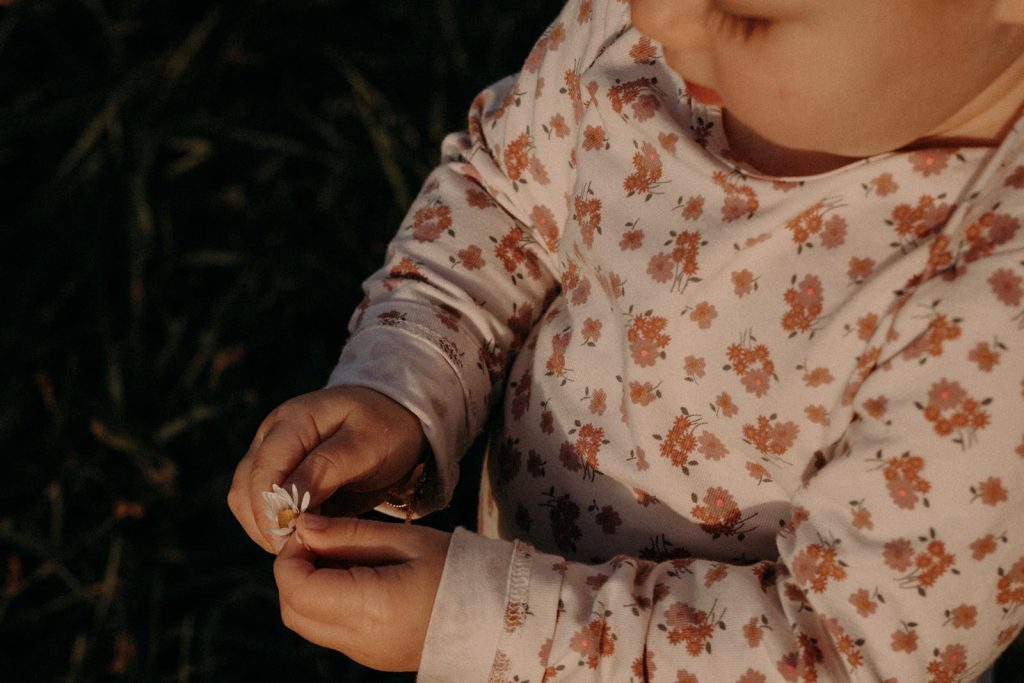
273, 514, 452, 671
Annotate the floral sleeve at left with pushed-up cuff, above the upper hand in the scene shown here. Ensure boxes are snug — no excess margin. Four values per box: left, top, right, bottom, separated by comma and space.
329, 0, 627, 511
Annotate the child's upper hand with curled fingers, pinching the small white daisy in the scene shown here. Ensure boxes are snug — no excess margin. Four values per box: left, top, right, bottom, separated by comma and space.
227, 386, 426, 552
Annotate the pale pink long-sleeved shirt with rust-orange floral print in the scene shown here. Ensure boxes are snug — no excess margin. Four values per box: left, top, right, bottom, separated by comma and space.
331, 0, 1024, 683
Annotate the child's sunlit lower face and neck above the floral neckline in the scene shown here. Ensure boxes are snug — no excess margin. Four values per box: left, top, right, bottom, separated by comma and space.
632, 0, 1024, 170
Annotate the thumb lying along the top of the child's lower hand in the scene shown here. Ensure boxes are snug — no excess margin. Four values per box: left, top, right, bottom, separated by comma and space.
297, 513, 418, 566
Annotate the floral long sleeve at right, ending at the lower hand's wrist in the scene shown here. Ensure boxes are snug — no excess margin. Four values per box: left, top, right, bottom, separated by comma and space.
423, 232, 1024, 683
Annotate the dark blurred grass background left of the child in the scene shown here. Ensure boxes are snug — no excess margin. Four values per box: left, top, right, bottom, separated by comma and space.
0, 0, 561, 682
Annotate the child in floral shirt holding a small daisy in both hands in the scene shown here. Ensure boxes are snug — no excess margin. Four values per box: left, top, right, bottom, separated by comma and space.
230, 0, 1024, 683
